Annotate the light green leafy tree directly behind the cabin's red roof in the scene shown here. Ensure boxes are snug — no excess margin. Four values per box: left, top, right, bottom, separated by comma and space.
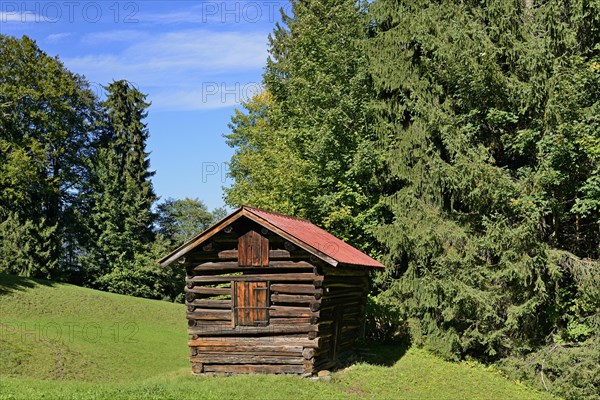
225, 0, 381, 250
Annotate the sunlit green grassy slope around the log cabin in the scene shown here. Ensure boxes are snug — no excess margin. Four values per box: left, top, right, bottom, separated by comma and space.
0, 275, 548, 399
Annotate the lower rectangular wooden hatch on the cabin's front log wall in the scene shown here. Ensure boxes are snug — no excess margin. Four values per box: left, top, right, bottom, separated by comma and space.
232, 282, 269, 326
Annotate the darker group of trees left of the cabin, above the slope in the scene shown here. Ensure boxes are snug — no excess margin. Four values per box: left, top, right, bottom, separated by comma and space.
0, 36, 224, 300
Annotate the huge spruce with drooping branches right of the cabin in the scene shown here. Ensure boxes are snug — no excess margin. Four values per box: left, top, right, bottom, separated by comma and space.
369, 0, 600, 360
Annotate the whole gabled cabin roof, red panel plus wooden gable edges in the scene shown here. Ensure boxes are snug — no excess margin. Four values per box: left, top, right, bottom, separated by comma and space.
159, 206, 385, 268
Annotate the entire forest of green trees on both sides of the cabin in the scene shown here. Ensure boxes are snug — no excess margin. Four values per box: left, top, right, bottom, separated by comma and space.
0, 0, 600, 399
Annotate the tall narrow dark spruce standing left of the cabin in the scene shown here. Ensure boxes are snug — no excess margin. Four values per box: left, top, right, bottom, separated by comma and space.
85, 80, 156, 282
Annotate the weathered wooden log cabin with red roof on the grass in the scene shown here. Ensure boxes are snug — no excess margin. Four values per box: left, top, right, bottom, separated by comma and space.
160, 207, 383, 375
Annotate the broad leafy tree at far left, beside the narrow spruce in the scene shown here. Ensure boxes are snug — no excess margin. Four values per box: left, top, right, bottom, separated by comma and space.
0, 35, 97, 278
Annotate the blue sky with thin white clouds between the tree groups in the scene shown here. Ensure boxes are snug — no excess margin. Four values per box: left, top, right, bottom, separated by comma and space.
0, 0, 290, 209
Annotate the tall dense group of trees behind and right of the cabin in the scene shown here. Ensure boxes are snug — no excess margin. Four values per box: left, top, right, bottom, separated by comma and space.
226, 0, 600, 398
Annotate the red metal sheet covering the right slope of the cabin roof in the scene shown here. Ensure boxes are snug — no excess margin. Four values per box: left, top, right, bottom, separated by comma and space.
243, 206, 384, 268
